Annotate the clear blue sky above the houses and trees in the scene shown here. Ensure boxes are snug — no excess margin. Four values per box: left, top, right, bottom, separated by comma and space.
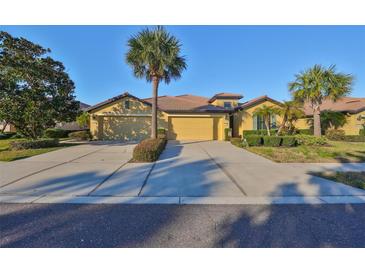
0, 26, 365, 104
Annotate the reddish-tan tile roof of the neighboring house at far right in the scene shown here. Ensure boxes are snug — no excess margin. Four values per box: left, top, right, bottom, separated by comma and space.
304, 97, 365, 115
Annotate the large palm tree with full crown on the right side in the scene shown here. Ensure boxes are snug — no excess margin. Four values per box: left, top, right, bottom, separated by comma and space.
289, 65, 353, 136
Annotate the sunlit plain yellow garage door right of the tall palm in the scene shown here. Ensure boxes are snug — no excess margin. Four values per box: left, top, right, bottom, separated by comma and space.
168, 117, 218, 140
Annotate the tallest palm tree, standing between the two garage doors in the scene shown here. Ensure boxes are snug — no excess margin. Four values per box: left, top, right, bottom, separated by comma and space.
126, 26, 186, 138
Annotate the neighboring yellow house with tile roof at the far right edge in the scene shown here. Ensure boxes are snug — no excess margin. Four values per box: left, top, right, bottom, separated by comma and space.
295, 97, 365, 135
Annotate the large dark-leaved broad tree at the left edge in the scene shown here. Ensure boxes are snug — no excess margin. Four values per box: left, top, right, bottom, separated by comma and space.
0, 32, 79, 139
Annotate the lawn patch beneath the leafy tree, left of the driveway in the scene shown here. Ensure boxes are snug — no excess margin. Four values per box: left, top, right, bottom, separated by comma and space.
0, 139, 77, 162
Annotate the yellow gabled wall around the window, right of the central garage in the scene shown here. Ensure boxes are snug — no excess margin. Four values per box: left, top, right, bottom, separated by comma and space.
233, 101, 282, 136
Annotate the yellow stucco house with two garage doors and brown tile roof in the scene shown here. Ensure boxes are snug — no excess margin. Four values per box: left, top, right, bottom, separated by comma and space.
88, 92, 365, 141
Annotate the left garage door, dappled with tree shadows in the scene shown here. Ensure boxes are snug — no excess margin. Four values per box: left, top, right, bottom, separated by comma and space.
101, 116, 151, 141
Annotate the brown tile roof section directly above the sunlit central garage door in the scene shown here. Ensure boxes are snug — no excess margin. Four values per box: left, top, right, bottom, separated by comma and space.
143, 94, 225, 112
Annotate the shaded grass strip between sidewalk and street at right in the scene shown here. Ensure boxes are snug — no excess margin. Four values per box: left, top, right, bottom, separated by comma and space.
313, 171, 365, 189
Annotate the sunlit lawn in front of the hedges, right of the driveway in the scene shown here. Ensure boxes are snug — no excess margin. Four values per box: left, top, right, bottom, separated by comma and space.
245, 141, 365, 163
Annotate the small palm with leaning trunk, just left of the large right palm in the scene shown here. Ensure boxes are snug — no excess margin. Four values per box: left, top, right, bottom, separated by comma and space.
277, 101, 304, 135
